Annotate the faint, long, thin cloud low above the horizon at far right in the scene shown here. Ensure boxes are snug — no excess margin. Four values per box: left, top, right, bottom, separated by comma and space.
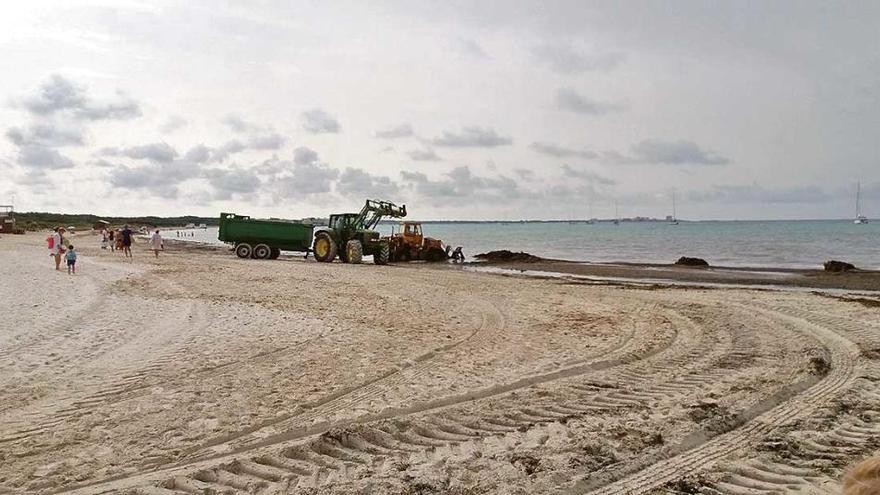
687, 184, 834, 204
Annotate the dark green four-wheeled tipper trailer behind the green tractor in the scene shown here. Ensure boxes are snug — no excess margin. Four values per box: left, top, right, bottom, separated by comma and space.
217, 213, 315, 259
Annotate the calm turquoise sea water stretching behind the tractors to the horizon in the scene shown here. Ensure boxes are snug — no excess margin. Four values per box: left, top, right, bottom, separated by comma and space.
164, 220, 880, 269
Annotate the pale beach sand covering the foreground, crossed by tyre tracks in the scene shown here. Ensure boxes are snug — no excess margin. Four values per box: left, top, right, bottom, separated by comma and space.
0, 235, 880, 494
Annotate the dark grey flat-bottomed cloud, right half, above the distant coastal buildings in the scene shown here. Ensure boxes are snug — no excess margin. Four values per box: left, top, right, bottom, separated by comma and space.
601, 139, 731, 165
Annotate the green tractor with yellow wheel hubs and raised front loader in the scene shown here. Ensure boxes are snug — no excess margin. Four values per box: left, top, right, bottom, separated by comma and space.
312, 199, 406, 265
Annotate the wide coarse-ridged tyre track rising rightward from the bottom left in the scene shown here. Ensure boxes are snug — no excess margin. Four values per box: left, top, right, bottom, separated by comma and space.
117, 304, 760, 494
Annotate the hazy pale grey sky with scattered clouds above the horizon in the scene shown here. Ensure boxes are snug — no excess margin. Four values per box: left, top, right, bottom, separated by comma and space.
0, 0, 880, 220
